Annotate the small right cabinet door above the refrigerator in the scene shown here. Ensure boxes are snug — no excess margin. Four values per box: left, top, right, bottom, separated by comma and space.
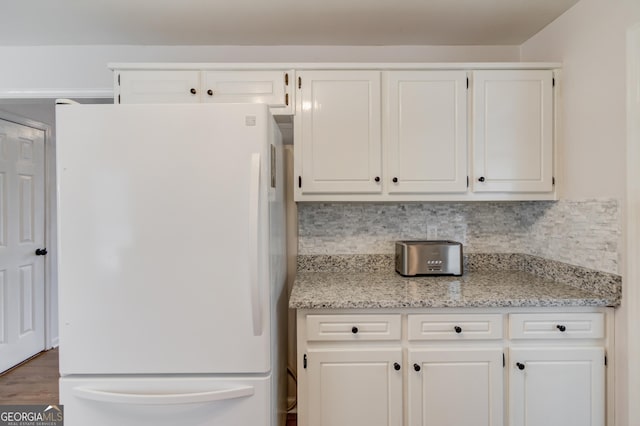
202, 71, 293, 110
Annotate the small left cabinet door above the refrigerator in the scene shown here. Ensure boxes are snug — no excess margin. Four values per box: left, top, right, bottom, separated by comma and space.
116, 70, 200, 104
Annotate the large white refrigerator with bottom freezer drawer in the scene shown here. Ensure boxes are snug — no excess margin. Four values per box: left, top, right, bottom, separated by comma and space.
56, 104, 286, 426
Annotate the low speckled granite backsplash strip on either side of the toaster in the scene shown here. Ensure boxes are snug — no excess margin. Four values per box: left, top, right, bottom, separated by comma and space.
297, 253, 622, 301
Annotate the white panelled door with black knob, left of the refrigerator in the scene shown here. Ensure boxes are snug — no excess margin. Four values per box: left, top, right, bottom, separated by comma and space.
0, 120, 45, 371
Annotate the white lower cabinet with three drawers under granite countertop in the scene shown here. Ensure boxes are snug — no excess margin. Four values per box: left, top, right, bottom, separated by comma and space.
297, 308, 614, 426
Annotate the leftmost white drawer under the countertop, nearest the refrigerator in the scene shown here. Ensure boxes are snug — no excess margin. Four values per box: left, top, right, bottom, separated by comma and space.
307, 315, 401, 341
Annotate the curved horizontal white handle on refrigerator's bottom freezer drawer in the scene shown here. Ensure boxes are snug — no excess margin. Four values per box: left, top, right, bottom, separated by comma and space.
73, 386, 254, 405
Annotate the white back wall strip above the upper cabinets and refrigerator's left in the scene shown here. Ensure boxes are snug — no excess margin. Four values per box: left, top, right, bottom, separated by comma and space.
0, 46, 520, 98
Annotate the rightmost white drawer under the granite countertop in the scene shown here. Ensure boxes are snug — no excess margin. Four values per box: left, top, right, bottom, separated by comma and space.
509, 312, 604, 339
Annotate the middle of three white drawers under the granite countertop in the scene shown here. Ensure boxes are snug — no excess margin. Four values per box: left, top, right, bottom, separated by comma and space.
408, 314, 503, 340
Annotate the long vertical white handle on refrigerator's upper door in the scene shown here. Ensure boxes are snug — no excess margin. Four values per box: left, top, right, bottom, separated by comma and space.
249, 152, 262, 336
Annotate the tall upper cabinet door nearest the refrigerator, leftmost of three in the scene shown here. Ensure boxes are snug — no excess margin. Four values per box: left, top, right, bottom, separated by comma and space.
294, 70, 382, 194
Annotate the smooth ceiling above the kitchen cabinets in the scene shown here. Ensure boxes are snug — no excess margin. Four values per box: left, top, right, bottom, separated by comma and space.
0, 0, 578, 46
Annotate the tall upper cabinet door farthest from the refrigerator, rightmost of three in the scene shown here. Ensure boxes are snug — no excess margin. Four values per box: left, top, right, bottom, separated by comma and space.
472, 70, 553, 192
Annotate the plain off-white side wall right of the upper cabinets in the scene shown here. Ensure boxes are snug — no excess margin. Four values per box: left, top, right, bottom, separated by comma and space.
521, 0, 640, 199
